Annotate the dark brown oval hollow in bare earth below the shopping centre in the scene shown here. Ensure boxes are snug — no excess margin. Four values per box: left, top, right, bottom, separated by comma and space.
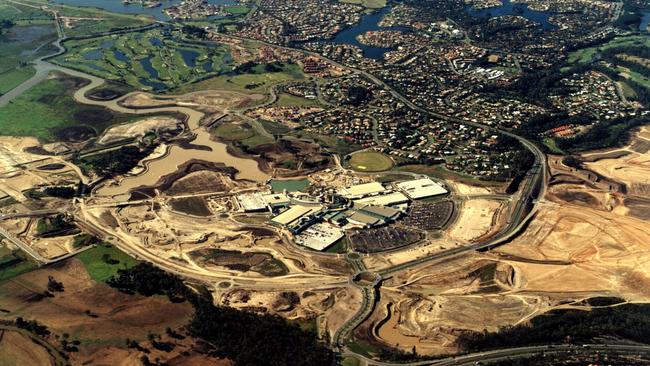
188, 248, 289, 277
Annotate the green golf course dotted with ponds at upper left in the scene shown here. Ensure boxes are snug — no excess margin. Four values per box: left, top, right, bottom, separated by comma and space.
55, 29, 232, 90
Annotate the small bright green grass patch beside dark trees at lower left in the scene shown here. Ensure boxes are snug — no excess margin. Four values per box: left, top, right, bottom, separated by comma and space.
75, 244, 138, 282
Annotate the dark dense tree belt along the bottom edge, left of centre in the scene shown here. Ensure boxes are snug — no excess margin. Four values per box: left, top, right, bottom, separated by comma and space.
108, 263, 334, 366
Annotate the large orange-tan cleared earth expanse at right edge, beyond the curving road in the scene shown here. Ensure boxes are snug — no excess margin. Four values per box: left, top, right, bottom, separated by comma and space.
498, 206, 650, 301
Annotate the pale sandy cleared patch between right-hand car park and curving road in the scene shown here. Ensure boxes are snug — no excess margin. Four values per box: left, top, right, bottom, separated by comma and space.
449, 199, 502, 242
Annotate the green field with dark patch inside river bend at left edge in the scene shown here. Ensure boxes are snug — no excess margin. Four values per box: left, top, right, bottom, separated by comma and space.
0, 74, 139, 142
